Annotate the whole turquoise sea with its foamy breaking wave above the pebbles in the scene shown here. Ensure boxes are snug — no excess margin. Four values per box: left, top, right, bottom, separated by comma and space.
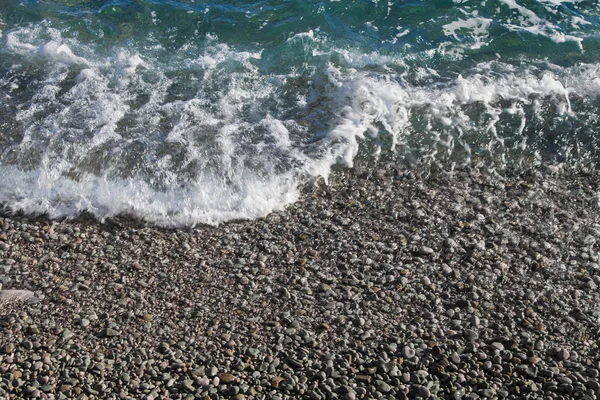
0, 0, 600, 226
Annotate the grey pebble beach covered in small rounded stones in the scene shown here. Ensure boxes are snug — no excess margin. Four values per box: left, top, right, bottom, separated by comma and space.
0, 166, 600, 399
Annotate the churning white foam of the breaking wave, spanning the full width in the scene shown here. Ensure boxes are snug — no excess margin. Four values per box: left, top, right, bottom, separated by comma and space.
0, 23, 600, 226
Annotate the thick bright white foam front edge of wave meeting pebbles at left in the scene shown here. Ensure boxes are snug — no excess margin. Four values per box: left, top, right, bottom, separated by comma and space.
0, 166, 298, 227
